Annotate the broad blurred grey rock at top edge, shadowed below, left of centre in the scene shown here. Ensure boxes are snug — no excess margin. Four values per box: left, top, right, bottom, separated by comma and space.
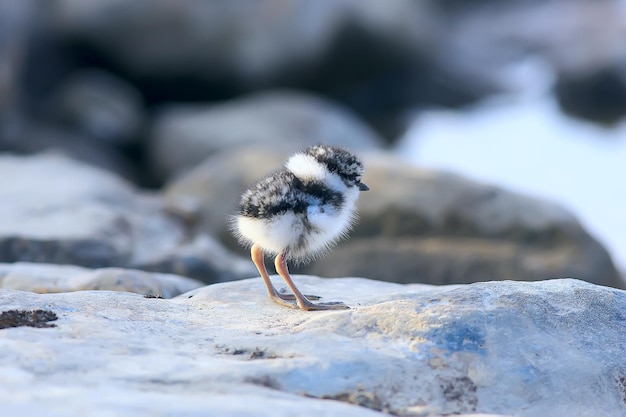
51, 0, 432, 89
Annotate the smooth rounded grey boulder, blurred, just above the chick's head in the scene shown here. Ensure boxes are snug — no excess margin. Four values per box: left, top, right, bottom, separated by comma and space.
150, 91, 382, 178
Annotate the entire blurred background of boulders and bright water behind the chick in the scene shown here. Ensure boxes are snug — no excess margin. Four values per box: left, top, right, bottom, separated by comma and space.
0, 0, 626, 287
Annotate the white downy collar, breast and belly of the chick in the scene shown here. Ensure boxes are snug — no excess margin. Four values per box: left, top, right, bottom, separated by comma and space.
234, 153, 359, 262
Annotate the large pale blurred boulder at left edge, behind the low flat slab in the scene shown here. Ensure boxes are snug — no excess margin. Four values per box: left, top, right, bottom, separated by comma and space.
0, 155, 254, 282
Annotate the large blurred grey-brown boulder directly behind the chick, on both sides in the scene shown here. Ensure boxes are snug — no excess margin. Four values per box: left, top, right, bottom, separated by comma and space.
164, 148, 624, 288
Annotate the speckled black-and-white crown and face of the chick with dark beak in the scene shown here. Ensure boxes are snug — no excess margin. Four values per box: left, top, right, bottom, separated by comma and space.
303, 145, 368, 191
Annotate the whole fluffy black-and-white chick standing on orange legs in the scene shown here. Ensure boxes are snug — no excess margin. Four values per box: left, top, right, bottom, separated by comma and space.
233, 145, 368, 310
